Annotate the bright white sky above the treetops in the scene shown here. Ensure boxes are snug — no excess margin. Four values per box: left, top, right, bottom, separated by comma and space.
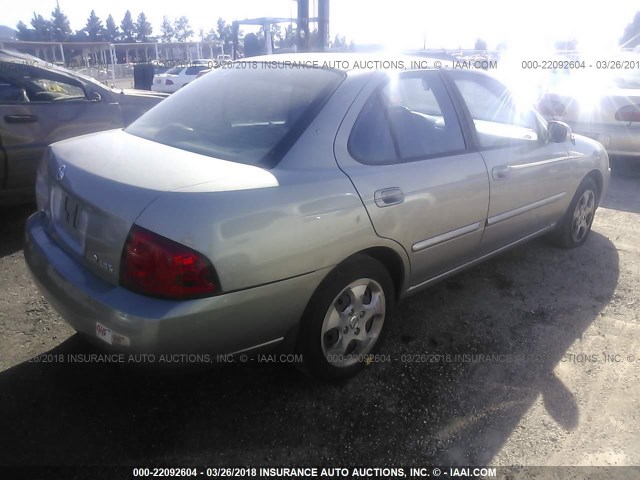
5, 0, 640, 50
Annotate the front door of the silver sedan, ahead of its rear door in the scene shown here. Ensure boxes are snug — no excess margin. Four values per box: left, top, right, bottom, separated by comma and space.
446, 70, 574, 253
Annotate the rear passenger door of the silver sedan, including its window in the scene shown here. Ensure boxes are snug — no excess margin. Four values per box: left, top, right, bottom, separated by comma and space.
335, 71, 489, 285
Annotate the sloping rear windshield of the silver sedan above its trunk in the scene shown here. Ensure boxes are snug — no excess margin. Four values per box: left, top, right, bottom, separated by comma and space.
126, 62, 344, 168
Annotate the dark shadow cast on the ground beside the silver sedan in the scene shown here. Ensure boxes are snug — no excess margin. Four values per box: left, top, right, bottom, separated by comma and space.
0, 232, 619, 465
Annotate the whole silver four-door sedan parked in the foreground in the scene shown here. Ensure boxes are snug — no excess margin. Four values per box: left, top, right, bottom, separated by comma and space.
25, 55, 610, 379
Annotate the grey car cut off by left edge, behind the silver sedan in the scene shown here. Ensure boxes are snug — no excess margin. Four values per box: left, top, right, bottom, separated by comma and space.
0, 50, 166, 203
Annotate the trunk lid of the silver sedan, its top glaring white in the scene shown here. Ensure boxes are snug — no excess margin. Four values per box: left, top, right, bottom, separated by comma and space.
42, 130, 274, 285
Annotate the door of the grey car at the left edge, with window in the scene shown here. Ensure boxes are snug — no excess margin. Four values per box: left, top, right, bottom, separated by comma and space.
0, 64, 122, 189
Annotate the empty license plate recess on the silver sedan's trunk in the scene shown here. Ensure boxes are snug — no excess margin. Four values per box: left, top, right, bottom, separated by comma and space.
51, 185, 89, 255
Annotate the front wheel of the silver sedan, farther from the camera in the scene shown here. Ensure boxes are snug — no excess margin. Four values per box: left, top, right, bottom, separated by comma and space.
549, 177, 600, 249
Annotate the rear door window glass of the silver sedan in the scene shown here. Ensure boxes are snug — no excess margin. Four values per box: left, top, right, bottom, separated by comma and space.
349, 72, 466, 165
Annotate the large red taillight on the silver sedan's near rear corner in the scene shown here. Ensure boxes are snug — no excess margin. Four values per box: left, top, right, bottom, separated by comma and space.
120, 225, 220, 300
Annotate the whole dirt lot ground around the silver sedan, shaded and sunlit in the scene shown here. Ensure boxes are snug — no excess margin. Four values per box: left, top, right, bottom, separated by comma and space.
0, 166, 640, 472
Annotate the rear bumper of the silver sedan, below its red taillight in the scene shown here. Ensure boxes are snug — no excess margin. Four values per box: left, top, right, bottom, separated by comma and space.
25, 212, 328, 353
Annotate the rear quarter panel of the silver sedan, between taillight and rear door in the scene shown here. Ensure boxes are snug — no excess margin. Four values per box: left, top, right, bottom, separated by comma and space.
136, 75, 409, 291
